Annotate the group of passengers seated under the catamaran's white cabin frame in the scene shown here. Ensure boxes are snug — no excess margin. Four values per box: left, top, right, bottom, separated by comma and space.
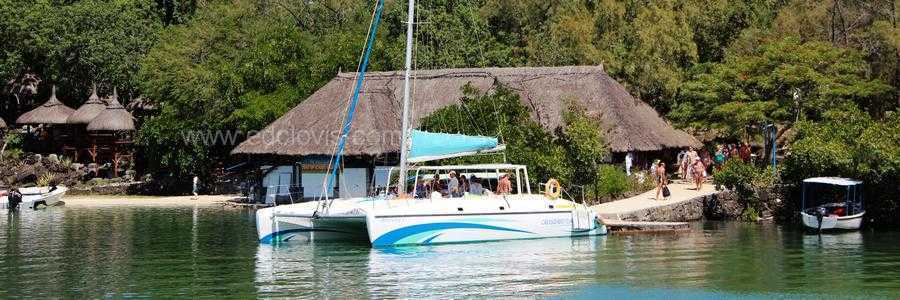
415, 171, 512, 198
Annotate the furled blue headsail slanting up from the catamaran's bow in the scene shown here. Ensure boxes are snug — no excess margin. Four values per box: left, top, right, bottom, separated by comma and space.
316, 0, 384, 213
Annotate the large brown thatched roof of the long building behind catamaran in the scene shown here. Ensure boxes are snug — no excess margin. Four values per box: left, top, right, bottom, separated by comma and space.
232, 66, 701, 156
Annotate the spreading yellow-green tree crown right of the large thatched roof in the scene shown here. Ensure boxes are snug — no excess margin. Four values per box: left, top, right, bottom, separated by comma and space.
669, 38, 892, 138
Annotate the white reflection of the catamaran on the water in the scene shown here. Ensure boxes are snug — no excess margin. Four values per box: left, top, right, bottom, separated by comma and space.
256, 236, 607, 299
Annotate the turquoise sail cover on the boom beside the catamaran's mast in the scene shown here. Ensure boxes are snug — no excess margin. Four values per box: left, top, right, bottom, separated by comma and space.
408, 130, 498, 162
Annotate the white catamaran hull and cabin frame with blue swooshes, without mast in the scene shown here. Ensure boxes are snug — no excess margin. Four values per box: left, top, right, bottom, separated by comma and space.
256, 164, 607, 247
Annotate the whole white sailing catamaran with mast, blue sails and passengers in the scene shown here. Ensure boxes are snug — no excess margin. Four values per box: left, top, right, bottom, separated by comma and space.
256, 0, 607, 247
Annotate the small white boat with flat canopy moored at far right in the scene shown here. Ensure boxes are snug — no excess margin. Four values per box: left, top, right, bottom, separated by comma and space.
800, 177, 866, 231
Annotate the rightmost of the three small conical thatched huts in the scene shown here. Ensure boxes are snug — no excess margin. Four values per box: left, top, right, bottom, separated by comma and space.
87, 89, 135, 177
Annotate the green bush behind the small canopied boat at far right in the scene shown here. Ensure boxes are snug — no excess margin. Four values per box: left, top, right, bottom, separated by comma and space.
783, 109, 900, 223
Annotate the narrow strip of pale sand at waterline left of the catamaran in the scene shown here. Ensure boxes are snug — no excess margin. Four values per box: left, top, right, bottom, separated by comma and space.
62, 195, 238, 207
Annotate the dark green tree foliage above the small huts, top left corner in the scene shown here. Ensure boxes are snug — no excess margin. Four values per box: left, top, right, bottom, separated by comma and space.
0, 0, 163, 100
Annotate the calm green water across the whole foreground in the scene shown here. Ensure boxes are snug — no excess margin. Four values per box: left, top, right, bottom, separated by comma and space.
0, 208, 900, 299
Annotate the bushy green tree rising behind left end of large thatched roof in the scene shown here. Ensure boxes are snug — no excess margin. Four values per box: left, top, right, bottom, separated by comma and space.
137, 2, 365, 174
